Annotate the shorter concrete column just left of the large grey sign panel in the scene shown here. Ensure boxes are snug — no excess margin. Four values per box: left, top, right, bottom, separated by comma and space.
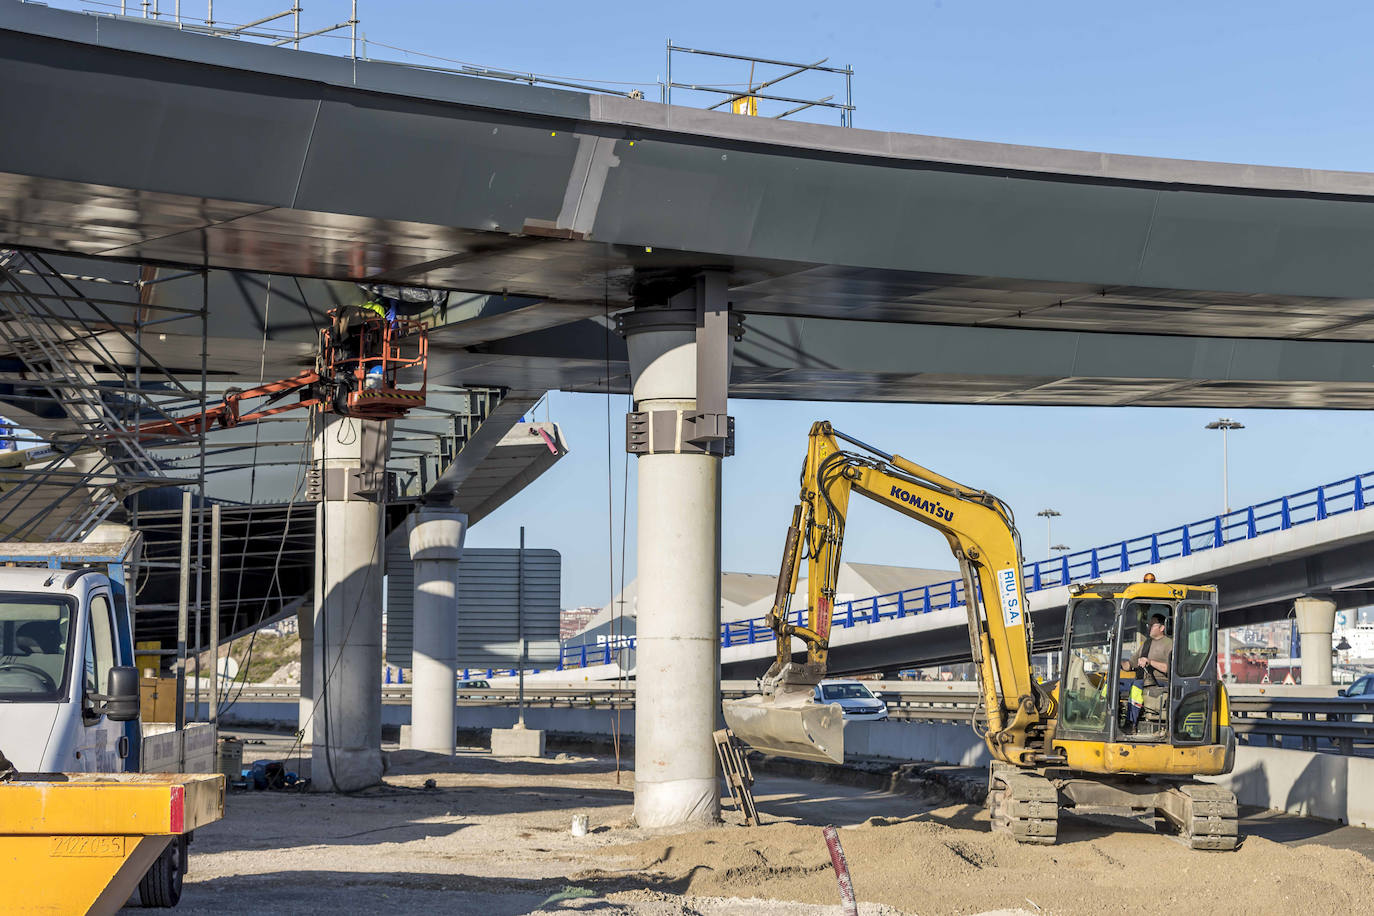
408, 507, 467, 755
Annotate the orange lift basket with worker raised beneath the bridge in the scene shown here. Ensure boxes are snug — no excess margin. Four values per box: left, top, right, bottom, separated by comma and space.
317, 306, 429, 420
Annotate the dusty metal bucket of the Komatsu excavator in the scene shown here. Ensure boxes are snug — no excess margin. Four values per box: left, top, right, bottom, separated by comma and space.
721, 688, 845, 764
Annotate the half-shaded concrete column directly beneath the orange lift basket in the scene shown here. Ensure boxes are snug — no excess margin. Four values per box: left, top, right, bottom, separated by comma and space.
311, 413, 390, 792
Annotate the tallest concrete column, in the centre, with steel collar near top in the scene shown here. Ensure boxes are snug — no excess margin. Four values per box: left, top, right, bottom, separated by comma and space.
622, 279, 728, 828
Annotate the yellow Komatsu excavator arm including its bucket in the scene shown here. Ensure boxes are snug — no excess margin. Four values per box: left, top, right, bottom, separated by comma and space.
725, 422, 1054, 766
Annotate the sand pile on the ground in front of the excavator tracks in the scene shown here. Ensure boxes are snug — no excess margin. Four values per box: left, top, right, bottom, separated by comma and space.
585, 808, 1374, 916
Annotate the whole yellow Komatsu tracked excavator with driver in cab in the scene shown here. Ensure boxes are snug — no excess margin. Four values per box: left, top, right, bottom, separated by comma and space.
723, 422, 1238, 850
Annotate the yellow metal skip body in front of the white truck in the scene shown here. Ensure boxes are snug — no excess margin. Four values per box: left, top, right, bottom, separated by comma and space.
0, 773, 224, 915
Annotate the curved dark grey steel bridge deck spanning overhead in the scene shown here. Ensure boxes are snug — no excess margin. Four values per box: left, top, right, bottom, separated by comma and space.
8, 4, 1374, 408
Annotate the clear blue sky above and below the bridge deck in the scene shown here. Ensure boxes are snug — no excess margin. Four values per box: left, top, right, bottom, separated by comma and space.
42, 0, 1374, 606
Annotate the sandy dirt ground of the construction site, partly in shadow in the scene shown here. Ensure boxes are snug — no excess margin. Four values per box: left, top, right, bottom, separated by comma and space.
136, 744, 1374, 916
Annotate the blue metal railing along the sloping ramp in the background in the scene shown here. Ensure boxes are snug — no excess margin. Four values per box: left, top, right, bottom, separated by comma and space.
559, 471, 1374, 667
